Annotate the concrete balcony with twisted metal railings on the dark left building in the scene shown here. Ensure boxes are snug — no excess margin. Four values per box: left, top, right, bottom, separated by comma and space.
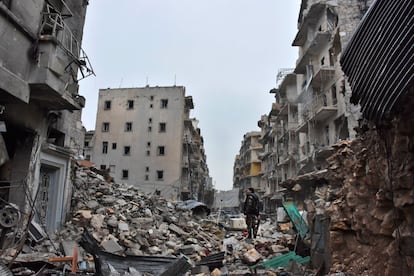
29, 9, 94, 110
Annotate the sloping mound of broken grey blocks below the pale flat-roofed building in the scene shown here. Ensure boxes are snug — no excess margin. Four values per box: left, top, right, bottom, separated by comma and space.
60, 164, 223, 261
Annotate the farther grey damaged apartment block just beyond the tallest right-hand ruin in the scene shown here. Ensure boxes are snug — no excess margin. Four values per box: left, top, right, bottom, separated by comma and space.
258, 69, 298, 212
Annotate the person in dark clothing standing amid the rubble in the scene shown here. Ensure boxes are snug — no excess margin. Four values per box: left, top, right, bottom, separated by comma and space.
243, 188, 260, 239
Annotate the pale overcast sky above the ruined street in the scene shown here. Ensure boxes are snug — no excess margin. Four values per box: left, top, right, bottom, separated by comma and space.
79, 0, 300, 190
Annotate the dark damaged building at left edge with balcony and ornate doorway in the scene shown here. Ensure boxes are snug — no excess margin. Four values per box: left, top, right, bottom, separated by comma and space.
0, 0, 93, 233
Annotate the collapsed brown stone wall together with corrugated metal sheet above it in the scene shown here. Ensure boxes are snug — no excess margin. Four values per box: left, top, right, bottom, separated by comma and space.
328, 1, 414, 275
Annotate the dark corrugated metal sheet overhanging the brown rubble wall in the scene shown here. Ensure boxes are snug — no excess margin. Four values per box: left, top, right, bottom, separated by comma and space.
341, 0, 414, 122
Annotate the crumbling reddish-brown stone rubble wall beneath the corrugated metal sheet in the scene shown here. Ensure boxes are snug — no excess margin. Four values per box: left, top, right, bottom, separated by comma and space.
325, 99, 414, 275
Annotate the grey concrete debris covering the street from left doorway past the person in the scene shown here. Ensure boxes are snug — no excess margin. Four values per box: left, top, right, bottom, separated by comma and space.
0, 161, 314, 276
